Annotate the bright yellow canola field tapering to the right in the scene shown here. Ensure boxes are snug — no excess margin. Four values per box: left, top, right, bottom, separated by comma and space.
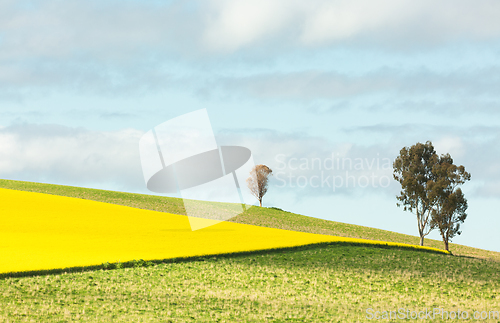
0, 189, 450, 273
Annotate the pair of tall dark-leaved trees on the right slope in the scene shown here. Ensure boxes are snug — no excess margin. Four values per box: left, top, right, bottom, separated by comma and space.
393, 141, 470, 250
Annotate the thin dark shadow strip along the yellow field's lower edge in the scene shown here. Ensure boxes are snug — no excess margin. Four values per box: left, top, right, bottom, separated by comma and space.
0, 241, 452, 279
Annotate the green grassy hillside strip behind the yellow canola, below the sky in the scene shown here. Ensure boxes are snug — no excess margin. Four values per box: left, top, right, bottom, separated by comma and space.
0, 179, 500, 261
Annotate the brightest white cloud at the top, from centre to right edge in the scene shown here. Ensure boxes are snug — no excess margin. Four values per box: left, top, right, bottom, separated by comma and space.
205, 0, 500, 51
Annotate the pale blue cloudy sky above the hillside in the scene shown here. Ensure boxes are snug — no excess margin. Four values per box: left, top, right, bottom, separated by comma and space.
0, 0, 500, 251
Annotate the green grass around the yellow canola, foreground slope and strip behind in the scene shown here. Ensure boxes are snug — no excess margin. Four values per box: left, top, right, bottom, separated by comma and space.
0, 180, 500, 322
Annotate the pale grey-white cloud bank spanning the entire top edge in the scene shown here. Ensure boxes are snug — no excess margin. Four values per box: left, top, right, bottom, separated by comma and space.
0, 0, 500, 61
